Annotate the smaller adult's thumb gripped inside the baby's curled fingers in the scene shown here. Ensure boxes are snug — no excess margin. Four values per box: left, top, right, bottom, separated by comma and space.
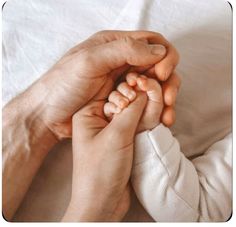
103, 92, 147, 149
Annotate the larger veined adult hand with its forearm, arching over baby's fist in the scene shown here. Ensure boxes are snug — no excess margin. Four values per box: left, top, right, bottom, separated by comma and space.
3, 31, 179, 220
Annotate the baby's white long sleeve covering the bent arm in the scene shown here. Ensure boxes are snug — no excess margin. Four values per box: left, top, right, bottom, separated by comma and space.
131, 124, 232, 222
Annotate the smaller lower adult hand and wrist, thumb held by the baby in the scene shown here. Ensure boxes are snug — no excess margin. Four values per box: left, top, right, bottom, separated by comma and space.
63, 82, 147, 221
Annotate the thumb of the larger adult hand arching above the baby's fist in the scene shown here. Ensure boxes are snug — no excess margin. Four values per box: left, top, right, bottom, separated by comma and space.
78, 37, 167, 74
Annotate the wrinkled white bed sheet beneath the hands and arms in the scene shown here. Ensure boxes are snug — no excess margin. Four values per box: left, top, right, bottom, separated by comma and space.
2, 0, 232, 221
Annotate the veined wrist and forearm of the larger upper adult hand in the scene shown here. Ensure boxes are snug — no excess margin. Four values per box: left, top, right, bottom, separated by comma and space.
2, 80, 57, 220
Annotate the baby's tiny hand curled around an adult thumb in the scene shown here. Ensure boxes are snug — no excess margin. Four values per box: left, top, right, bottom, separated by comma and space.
104, 72, 163, 132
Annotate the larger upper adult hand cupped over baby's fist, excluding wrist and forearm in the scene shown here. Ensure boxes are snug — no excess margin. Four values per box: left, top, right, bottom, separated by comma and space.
36, 31, 178, 139
